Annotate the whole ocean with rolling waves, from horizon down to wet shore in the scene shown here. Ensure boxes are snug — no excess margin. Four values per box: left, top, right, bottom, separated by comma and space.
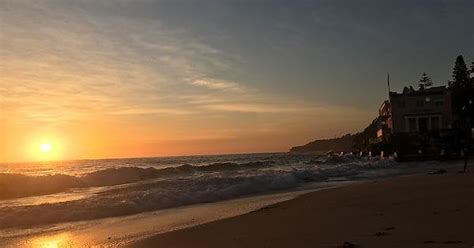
0, 153, 460, 246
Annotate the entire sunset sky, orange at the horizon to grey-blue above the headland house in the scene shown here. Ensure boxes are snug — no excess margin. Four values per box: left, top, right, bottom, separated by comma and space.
0, 0, 474, 162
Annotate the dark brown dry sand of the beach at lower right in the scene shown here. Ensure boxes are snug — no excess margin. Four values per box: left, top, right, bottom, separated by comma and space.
132, 172, 474, 248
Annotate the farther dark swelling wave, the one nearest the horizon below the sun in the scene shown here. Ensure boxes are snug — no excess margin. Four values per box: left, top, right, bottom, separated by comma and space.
0, 161, 275, 200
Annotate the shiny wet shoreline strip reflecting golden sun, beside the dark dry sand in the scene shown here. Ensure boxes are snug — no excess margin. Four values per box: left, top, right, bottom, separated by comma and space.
0, 183, 322, 248
